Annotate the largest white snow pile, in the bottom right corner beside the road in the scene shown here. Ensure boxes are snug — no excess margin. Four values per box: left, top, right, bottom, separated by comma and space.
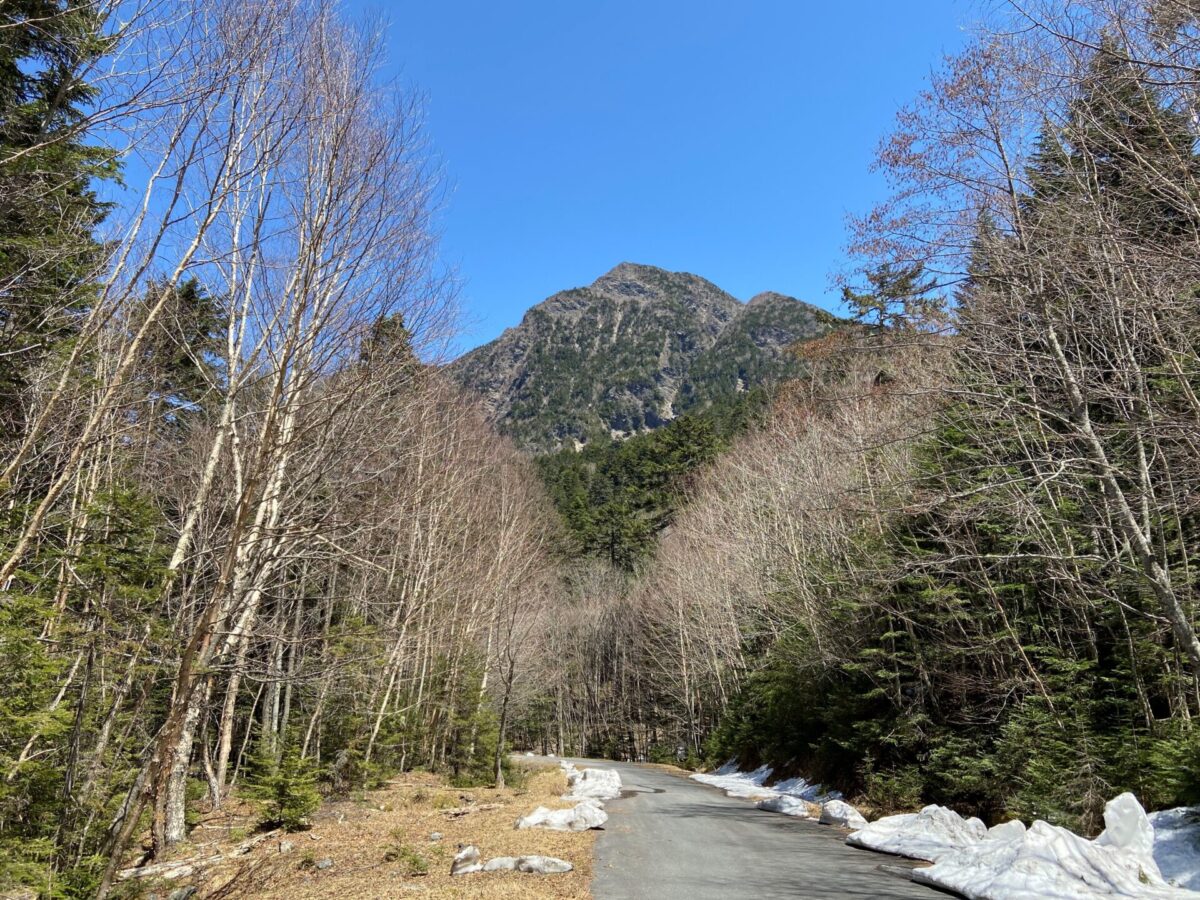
902, 793, 1200, 900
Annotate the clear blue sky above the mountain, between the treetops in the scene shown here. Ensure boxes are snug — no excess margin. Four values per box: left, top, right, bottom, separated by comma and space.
348, 0, 972, 348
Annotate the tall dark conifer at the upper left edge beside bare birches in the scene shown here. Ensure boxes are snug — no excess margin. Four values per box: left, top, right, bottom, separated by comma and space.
0, 0, 116, 442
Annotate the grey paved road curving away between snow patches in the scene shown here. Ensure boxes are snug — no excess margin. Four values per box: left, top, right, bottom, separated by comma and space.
576, 761, 946, 900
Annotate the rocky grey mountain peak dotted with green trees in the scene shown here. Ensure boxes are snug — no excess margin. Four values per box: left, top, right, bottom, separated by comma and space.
449, 263, 840, 450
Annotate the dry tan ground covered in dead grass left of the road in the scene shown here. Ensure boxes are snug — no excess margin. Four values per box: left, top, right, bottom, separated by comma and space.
126, 763, 595, 900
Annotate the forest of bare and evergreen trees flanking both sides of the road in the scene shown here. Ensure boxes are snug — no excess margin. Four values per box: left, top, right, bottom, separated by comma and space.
7, 0, 1200, 898
